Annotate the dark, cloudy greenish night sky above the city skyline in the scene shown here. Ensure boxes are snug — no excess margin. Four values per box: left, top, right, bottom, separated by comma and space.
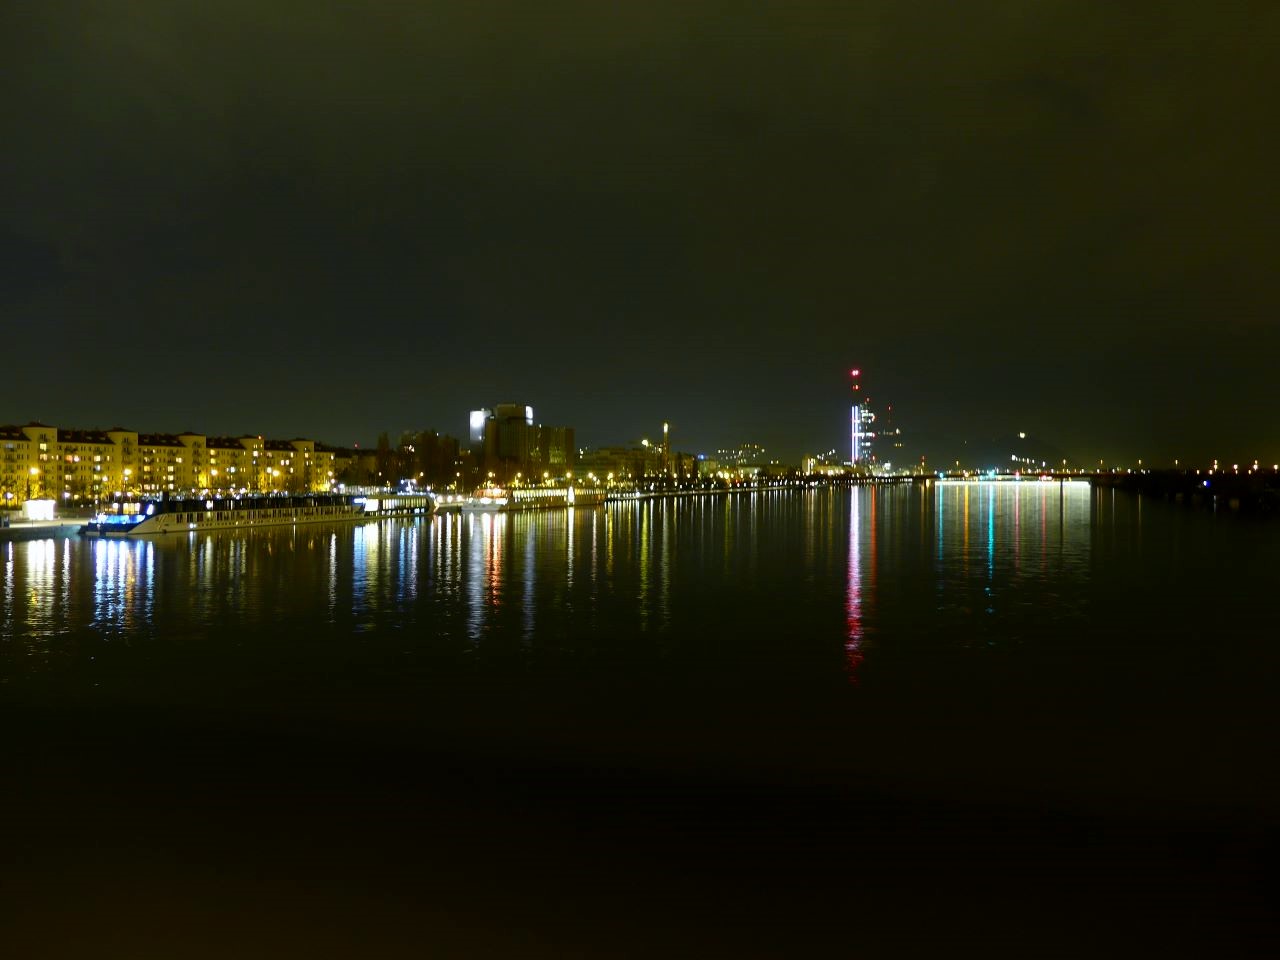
0, 0, 1280, 463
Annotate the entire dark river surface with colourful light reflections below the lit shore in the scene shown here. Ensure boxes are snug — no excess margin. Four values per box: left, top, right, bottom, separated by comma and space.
0, 484, 1280, 957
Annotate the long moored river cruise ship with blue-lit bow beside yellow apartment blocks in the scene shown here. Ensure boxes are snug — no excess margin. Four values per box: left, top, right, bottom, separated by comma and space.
79, 493, 436, 538
